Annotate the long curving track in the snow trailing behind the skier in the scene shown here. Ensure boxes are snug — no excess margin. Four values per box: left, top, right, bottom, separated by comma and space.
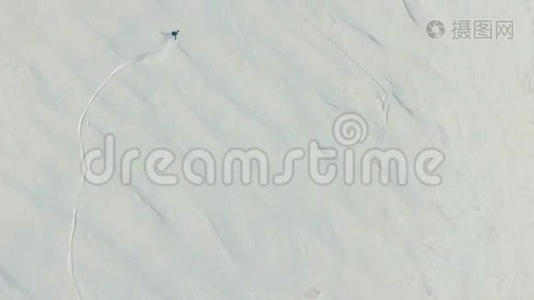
68, 37, 175, 300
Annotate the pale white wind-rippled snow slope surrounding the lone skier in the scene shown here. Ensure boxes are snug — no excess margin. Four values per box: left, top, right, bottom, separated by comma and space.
0, 0, 534, 300
